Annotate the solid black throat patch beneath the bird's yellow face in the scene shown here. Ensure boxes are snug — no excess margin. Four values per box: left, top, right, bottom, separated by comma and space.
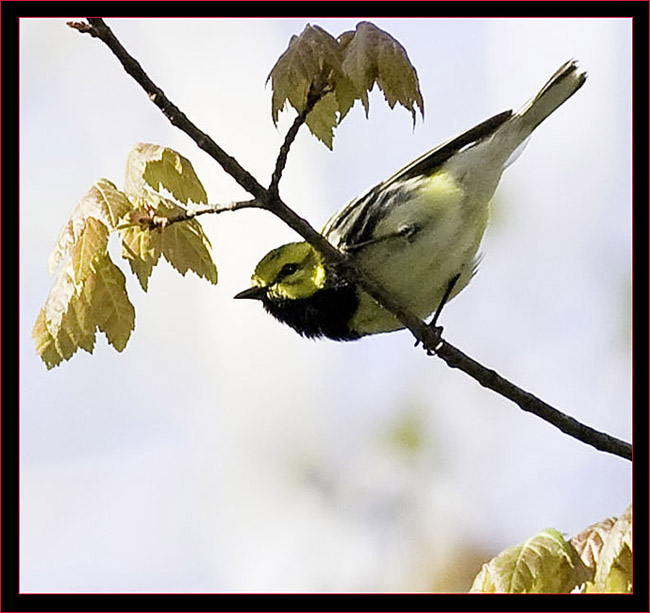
262, 283, 361, 341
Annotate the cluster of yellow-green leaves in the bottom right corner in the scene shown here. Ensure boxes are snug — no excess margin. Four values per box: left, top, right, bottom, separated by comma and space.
470, 506, 632, 593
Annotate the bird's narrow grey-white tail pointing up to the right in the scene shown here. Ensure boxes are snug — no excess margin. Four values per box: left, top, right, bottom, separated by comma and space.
513, 60, 587, 133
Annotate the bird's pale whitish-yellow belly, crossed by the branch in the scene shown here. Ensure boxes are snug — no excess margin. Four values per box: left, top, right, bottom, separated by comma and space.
351, 172, 494, 334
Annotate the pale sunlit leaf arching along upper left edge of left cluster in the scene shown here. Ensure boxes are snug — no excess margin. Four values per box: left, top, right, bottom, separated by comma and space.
48, 179, 133, 274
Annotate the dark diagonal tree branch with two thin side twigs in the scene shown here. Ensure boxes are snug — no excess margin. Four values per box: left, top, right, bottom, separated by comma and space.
68, 18, 632, 460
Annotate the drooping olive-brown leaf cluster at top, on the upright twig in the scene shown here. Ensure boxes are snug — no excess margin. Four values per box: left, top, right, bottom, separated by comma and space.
268, 21, 424, 149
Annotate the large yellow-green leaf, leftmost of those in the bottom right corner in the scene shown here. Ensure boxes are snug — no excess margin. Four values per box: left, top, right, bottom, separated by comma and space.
470, 529, 585, 593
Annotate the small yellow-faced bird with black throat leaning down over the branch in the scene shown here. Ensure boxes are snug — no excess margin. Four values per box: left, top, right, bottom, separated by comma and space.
235, 61, 586, 340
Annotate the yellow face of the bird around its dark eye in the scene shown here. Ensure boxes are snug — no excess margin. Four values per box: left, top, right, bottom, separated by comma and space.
252, 242, 326, 300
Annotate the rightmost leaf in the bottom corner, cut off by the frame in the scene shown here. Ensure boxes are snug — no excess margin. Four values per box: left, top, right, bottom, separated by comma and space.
587, 506, 633, 593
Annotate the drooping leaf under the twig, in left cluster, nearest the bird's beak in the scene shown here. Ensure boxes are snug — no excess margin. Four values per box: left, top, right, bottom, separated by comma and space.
157, 199, 217, 284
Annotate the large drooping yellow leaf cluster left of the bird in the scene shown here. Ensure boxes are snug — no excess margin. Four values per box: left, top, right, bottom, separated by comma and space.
32, 143, 217, 368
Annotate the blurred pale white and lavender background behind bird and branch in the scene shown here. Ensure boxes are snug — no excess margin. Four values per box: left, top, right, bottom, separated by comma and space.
20, 18, 632, 592
